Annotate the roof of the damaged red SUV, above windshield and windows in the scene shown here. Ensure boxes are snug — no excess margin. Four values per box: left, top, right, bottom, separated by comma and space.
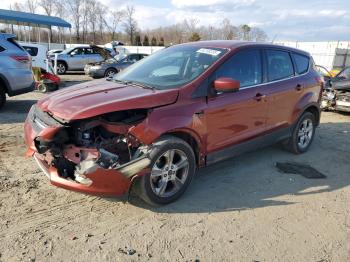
181, 40, 310, 56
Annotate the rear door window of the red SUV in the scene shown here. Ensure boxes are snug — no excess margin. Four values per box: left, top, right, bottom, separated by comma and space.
266, 50, 294, 81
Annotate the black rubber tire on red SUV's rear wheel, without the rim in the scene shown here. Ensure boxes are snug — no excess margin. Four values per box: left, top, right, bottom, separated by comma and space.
283, 112, 317, 154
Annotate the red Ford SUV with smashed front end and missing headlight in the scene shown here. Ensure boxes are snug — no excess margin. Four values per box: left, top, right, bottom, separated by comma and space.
25, 41, 323, 205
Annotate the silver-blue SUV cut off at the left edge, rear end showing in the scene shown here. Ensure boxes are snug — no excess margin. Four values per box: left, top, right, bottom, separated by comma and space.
0, 34, 35, 108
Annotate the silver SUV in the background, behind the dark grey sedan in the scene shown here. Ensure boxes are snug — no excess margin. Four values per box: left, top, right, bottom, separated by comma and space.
50, 46, 108, 75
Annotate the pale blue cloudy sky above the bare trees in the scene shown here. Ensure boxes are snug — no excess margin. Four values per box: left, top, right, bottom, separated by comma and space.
0, 0, 350, 41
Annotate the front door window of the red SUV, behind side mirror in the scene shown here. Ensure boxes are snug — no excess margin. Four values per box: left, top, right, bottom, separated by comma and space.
215, 50, 262, 87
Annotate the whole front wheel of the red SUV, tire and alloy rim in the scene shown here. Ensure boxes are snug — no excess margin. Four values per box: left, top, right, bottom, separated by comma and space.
135, 136, 196, 206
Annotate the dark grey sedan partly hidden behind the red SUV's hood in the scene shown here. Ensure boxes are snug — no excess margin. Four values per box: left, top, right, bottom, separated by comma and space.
84, 54, 148, 78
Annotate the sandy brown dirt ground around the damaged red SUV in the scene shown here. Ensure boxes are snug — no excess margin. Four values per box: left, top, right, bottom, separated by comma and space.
0, 74, 350, 262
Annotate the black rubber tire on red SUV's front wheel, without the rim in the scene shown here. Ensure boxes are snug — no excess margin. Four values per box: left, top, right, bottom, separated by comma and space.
135, 136, 196, 206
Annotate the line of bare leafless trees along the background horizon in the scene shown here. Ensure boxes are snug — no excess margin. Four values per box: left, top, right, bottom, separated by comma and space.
5, 0, 268, 46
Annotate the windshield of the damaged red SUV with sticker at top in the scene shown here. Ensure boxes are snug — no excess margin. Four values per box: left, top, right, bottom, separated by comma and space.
114, 46, 226, 89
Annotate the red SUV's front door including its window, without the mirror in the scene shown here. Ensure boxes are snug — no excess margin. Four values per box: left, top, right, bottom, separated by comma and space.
205, 49, 268, 154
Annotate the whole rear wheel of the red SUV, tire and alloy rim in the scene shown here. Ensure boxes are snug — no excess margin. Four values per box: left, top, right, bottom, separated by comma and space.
284, 112, 316, 154
